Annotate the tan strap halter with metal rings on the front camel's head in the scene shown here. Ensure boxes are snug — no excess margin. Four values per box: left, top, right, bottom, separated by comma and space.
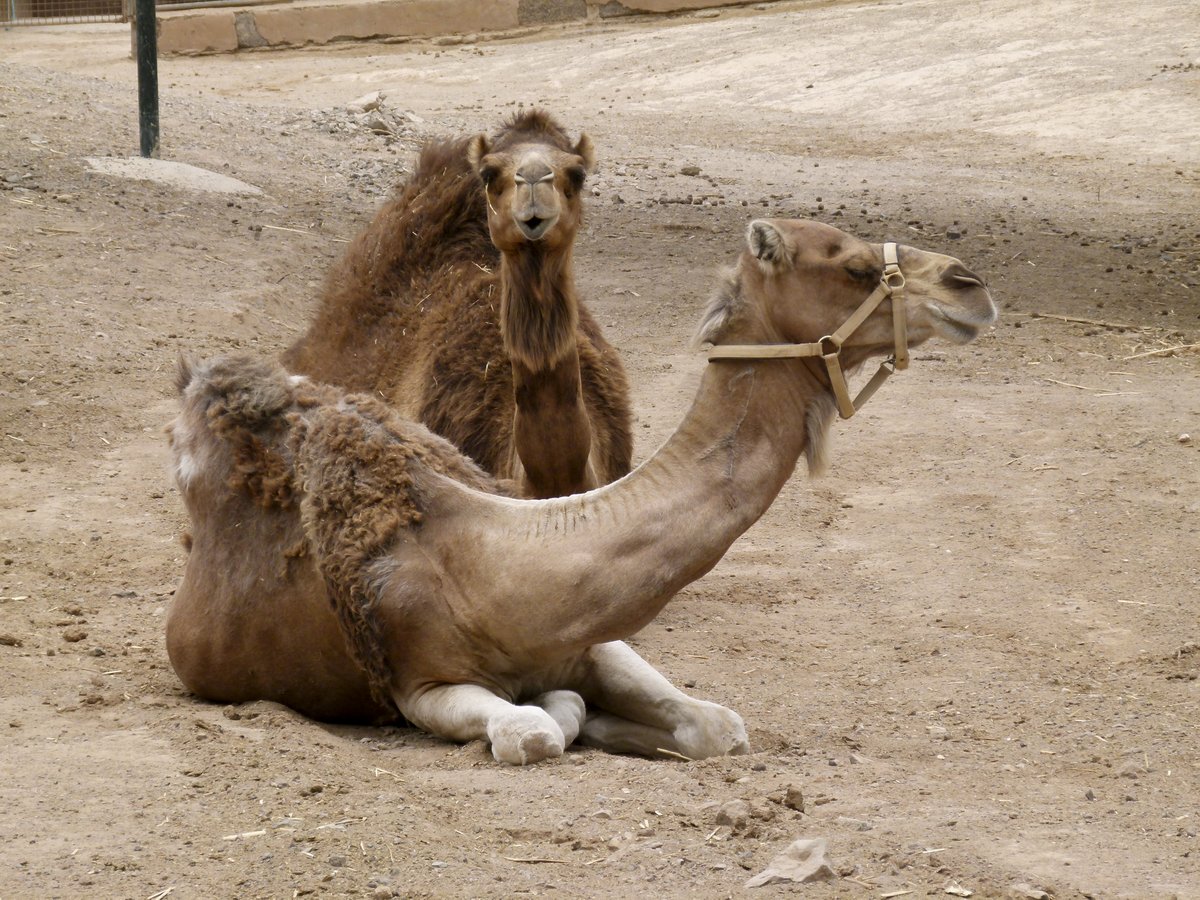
708, 242, 908, 419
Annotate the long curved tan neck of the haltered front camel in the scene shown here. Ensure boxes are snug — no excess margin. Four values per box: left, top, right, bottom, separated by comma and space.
477, 350, 832, 652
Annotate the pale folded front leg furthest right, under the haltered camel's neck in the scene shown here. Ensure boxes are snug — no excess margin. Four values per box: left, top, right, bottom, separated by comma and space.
571, 641, 750, 760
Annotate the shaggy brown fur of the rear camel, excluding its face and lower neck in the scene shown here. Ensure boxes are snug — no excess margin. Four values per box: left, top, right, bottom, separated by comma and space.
283, 112, 632, 493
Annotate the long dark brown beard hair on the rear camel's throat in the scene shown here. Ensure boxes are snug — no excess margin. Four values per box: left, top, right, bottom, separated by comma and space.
500, 246, 580, 371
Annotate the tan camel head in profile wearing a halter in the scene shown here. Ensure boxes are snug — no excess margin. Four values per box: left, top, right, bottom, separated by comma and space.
697, 218, 996, 370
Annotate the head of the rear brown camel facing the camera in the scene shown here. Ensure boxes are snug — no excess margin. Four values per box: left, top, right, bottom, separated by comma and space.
467, 112, 595, 253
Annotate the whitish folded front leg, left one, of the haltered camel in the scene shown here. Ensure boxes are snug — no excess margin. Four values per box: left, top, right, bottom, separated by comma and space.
397, 684, 583, 766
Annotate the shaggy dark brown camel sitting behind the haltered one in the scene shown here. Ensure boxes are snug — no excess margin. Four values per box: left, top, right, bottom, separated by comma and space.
283, 110, 632, 497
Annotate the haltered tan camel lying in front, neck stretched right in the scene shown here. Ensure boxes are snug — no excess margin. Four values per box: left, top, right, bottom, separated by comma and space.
167, 220, 995, 764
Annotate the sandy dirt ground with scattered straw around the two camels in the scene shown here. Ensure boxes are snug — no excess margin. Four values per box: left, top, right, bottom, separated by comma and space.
0, 0, 1200, 900
